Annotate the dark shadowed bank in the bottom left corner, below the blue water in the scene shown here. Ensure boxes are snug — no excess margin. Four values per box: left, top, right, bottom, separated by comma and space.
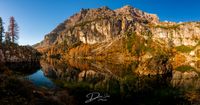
0, 75, 75, 105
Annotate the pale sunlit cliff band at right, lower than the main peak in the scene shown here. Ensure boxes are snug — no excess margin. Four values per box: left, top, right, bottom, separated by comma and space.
152, 22, 200, 46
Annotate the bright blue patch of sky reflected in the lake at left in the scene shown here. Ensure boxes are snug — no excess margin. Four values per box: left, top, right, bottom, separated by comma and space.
25, 70, 55, 88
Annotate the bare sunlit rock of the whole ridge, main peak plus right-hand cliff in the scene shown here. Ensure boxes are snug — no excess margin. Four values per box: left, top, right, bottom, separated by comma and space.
34, 6, 200, 50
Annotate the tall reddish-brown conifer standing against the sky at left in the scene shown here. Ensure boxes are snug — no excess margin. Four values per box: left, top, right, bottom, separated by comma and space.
8, 16, 19, 43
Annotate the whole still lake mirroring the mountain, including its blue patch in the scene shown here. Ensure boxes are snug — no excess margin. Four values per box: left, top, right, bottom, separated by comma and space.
5, 59, 200, 105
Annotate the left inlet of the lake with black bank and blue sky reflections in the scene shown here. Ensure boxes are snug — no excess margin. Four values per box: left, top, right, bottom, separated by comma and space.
6, 62, 55, 88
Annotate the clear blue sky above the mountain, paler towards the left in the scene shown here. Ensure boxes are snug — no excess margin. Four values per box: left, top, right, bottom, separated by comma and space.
0, 0, 200, 45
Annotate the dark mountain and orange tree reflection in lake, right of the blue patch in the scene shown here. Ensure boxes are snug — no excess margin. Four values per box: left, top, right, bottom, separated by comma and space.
41, 59, 190, 105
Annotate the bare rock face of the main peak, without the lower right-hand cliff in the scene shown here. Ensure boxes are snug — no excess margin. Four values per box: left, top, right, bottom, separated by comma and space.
35, 6, 159, 48
